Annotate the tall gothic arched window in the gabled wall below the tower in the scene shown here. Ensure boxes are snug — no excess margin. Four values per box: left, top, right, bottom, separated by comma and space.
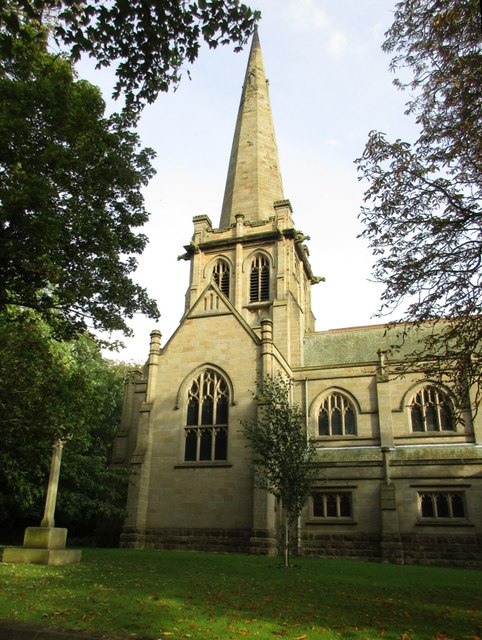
184, 369, 229, 462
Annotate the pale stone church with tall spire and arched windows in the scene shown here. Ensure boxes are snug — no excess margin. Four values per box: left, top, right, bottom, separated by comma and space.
114, 33, 482, 566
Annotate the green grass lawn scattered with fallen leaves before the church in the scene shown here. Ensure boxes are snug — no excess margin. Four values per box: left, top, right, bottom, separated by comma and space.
0, 549, 482, 640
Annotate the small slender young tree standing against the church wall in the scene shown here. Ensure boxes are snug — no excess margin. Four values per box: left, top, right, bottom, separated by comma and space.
241, 373, 314, 567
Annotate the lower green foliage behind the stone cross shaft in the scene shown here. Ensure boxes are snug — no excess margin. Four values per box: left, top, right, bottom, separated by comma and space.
0, 309, 127, 534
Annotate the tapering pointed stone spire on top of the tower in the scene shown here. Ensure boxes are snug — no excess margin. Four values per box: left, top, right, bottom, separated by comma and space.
219, 29, 284, 229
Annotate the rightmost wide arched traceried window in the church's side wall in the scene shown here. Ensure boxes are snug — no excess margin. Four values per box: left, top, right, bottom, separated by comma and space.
410, 387, 455, 432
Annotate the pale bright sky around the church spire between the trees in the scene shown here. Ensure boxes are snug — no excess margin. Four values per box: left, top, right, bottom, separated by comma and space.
79, 0, 413, 363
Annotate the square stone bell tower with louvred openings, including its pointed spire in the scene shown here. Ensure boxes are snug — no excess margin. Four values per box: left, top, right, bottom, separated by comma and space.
181, 31, 320, 366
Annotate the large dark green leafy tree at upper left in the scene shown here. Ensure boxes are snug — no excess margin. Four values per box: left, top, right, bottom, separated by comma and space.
0, 28, 159, 338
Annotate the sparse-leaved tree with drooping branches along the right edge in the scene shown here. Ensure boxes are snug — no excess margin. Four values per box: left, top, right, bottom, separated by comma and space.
356, 0, 482, 407
